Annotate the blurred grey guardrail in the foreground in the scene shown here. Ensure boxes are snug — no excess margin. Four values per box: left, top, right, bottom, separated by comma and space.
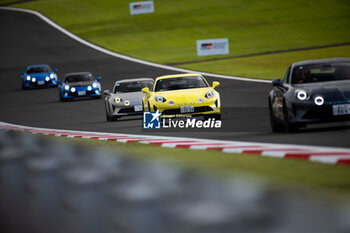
0, 130, 350, 233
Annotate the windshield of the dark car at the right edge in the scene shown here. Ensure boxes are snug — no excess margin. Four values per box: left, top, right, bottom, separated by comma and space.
292, 62, 350, 84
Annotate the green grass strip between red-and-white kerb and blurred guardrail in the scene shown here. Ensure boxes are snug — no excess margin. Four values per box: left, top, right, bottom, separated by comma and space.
44, 136, 350, 199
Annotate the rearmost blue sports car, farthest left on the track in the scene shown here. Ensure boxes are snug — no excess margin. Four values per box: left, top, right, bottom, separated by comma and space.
21, 65, 57, 89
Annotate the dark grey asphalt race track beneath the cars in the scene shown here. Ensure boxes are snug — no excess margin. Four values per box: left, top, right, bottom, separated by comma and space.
0, 10, 350, 147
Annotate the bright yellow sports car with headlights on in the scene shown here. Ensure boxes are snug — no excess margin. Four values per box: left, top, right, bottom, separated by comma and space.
142, 74, 221, 120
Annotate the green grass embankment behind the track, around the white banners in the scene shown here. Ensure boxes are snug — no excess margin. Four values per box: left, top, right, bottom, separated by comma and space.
11, 0, 350, 79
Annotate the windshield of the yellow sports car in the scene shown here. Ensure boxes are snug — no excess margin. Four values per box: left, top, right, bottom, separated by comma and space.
154, 76, 208, 92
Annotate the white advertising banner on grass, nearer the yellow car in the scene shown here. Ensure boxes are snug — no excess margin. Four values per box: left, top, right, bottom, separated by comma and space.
197, 38, 229, 56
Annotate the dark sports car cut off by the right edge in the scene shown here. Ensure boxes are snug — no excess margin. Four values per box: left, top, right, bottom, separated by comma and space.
269, 58, 350, 132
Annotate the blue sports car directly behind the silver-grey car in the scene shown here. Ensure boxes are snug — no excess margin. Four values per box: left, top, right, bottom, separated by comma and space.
58, 72, 101, 101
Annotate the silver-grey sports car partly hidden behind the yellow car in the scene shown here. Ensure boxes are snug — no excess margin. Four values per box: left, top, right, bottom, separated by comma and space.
104, 78, 154, 121
